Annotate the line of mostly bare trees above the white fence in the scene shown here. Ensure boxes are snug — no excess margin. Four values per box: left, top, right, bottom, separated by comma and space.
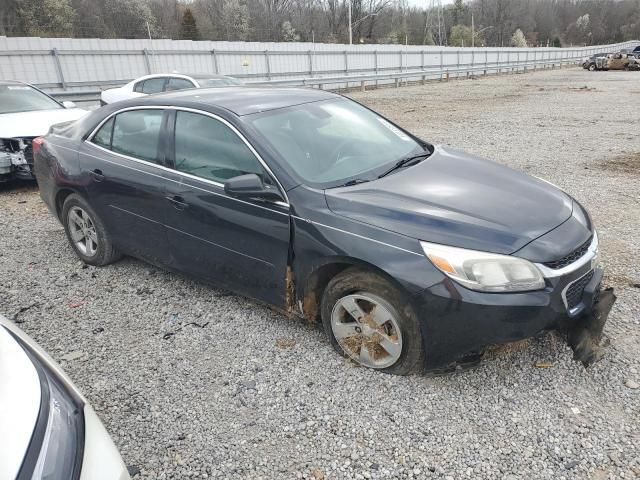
0, 0, 640, 47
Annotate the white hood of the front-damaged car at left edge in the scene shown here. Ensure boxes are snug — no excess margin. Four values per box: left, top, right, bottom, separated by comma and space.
0, 108, 87, 138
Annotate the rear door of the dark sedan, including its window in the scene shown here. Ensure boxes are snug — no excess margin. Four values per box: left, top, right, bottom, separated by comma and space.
80, 108, 176, 264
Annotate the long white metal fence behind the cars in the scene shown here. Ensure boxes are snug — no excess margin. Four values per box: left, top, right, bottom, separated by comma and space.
0, 37, 640, 101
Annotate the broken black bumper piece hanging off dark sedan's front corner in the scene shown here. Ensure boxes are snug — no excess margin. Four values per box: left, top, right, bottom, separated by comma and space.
567, 288, 616, 367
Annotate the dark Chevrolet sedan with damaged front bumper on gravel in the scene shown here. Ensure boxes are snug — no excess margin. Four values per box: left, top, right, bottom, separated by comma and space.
36, 88, 608, 374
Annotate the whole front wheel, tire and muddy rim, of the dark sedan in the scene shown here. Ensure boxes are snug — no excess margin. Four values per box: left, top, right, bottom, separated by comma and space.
321, 267, 424, 375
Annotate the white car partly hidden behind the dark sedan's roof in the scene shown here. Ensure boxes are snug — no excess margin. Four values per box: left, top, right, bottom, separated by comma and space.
100, 73, 242, 105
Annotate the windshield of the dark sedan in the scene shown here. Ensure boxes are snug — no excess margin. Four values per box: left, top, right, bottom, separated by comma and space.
245, 99, 425, 188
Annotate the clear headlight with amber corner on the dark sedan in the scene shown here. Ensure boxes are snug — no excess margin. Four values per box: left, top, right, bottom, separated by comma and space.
420, 242, 545, 292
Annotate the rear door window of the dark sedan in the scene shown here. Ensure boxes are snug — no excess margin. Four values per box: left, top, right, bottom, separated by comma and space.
96, 109, 163, 163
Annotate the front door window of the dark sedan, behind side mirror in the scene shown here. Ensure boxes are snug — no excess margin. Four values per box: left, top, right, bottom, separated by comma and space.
175, 111, 264, 183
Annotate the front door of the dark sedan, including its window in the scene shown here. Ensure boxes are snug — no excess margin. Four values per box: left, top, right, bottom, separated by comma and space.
166, 111, 289, 306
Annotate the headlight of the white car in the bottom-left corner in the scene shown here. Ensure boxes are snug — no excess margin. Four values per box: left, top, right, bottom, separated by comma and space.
18, 336, 84, 480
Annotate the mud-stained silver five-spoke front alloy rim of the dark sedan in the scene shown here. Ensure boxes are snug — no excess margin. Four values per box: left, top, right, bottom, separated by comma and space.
331, 293, 402, 368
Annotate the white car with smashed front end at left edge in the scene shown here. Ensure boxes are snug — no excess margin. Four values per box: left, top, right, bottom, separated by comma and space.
0, 80, 87, 182
